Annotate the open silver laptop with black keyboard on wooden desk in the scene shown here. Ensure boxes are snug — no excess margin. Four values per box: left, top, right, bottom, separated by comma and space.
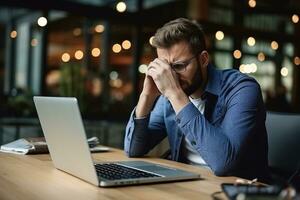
33, 96, 200, 187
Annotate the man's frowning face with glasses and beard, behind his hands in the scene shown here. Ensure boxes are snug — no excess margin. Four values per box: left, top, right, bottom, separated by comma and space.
157, 41, 204, 96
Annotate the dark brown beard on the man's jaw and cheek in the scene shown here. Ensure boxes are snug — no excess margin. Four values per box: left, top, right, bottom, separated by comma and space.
179, 60, 203, 96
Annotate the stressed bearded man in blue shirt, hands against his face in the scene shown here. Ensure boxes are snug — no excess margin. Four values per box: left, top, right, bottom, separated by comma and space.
125, 18, 267, 180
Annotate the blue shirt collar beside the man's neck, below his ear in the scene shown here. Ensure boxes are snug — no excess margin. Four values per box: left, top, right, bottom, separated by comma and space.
205, 64, 222, 96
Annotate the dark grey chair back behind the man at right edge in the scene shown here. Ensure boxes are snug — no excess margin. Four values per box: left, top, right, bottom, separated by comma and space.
266, 112, 300, 178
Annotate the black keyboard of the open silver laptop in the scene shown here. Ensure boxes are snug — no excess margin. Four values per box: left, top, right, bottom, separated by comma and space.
95, 163, 160, 180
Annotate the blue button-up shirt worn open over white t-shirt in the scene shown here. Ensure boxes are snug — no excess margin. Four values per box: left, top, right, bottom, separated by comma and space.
124, 65, 268, 178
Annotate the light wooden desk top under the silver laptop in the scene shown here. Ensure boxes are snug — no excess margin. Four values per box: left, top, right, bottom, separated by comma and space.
0, 149, 236, 200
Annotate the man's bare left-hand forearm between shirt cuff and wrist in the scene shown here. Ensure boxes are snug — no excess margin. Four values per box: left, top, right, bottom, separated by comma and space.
135, 93, 157, 118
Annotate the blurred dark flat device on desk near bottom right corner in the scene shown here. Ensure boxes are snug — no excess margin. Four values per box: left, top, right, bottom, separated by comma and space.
222, 183, 282, 200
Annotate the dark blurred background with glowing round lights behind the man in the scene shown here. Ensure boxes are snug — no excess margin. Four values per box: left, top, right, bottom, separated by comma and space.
0, 0, 300, 148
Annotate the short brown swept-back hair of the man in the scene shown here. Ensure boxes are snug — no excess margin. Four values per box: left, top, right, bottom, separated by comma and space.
152, 18, 206, 54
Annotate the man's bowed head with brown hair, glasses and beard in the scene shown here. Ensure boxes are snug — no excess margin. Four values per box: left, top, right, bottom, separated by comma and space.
153, 18, 209, 97
